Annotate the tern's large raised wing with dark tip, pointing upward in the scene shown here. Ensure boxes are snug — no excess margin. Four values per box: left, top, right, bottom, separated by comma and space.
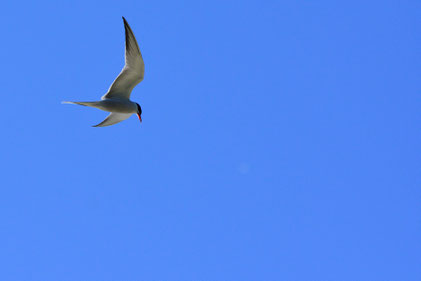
102, 17, 145, 99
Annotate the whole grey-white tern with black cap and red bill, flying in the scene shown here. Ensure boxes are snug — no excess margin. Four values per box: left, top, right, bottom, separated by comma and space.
62, 17, 145, 127
